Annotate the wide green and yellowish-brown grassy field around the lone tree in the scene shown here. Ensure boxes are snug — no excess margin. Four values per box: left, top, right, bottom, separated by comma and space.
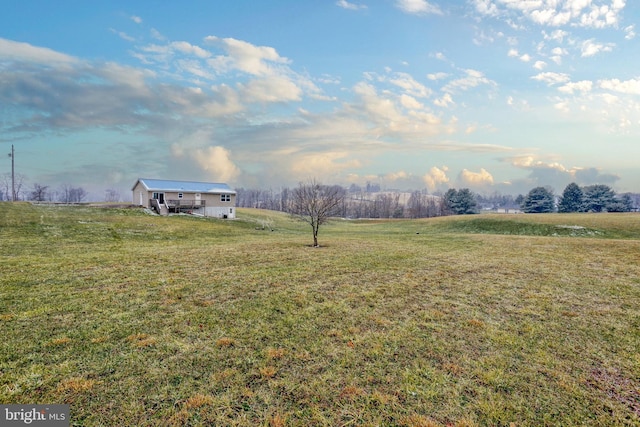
0, 203, 640, 427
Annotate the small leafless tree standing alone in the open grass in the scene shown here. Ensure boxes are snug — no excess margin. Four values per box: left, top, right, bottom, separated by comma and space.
289, 179, 345, 247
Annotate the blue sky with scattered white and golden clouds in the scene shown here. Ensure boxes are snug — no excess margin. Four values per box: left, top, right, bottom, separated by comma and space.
0, 0, 640, 200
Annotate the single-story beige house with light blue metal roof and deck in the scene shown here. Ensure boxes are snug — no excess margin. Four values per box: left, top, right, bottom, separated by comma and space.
131, 178, 236, 218
